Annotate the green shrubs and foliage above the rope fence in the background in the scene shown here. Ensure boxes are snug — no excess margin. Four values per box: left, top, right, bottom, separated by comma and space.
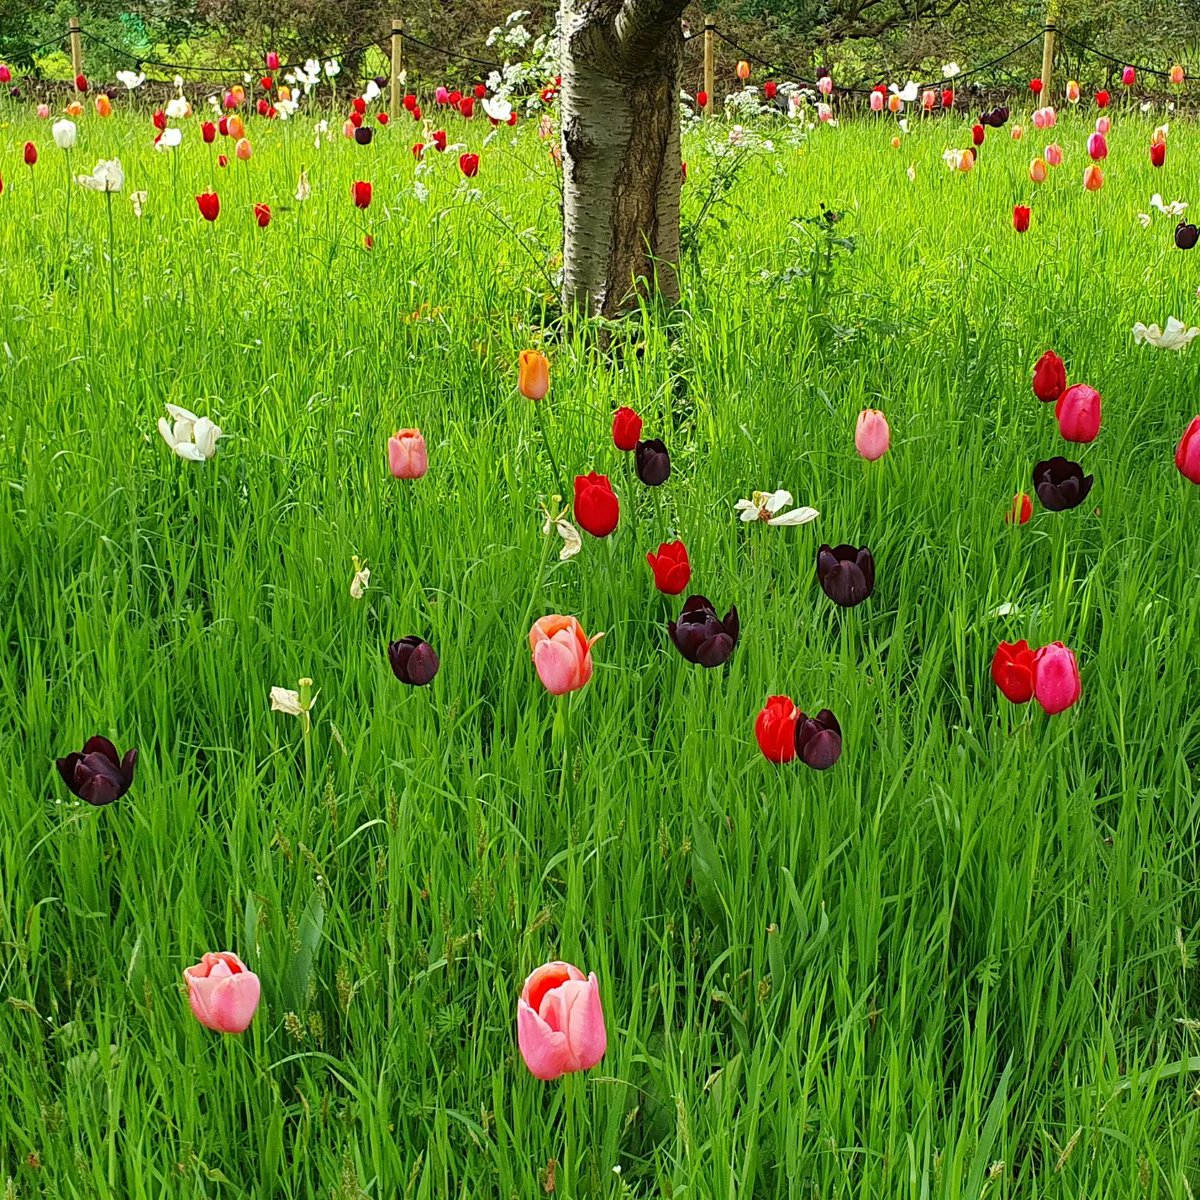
0, 0, 1200, 86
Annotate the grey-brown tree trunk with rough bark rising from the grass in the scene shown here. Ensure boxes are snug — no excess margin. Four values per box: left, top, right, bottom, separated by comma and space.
560, 0, 688, 317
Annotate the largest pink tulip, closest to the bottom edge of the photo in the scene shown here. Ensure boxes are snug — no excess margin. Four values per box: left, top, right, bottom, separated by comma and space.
517, 962, 608, 1079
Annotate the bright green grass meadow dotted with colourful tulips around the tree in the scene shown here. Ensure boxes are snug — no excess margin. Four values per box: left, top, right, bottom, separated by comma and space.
0, 64, 1200, 1200
